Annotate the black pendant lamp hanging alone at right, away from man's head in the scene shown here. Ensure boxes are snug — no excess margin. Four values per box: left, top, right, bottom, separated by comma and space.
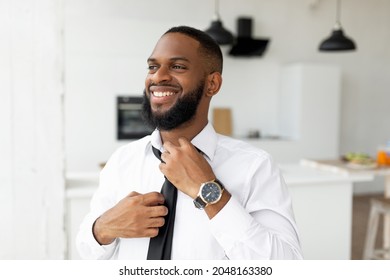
319, 0, 356, 52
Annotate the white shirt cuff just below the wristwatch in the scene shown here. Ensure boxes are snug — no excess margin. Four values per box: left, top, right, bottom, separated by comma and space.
210, 196, 253, 251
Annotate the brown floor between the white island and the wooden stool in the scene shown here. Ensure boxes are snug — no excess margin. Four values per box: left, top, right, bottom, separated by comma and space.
351, 195, 383, 260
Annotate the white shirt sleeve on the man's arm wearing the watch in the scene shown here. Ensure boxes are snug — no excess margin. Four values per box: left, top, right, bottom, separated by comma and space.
210, 154, 303, 260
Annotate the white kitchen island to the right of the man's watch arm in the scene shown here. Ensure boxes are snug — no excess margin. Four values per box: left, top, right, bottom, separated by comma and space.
282, 165, 373, 260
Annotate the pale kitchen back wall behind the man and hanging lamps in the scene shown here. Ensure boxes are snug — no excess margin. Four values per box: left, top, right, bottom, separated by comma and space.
65, 0, 390, 188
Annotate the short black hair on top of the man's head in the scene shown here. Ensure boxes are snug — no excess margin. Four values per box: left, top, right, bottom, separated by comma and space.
164, 25, 223, 74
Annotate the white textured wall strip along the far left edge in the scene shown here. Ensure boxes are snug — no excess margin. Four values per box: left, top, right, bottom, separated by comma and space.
0, 0, 65, 259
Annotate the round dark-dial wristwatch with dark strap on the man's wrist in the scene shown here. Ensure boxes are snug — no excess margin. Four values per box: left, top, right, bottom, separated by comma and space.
194, 179, 225, 210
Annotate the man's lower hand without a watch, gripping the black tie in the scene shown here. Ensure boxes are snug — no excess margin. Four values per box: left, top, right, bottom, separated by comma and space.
93, 192, 168, 245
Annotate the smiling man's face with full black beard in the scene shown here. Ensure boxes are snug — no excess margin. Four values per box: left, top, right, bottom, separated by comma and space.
144, 33, 206, 130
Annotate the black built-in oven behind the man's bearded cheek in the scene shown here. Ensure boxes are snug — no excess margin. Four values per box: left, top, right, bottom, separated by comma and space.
116, 96, 153, 140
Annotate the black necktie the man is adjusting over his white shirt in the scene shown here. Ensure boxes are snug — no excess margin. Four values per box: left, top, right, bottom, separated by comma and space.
147, 147, 177, 260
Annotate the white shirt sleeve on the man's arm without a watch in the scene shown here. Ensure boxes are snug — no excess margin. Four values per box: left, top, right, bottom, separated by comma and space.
76, 148, 119, 260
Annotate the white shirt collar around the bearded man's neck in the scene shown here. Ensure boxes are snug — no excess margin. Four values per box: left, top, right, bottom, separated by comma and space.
150, 123, 218, 160
